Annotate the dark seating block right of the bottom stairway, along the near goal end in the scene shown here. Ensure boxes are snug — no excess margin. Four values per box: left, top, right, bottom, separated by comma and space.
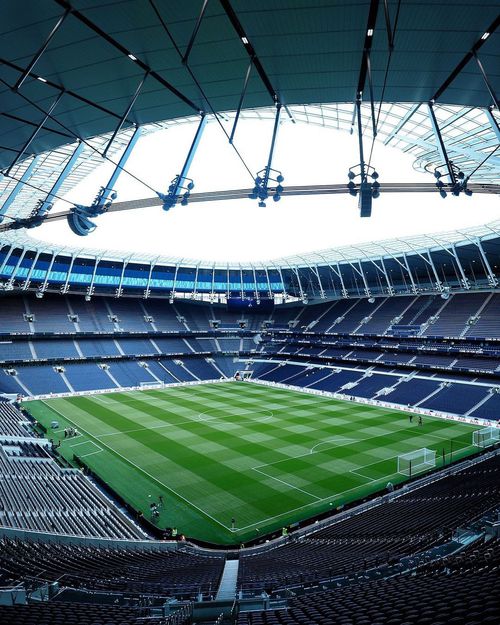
238, 456, 500, 592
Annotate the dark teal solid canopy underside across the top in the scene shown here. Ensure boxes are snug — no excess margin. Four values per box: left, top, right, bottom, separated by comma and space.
0, 0, 500, 167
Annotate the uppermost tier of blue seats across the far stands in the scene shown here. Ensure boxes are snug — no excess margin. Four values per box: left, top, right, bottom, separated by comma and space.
0, 293, 500, 337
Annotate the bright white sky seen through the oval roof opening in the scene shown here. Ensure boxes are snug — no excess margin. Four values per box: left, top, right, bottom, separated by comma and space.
36, 120, 499, 262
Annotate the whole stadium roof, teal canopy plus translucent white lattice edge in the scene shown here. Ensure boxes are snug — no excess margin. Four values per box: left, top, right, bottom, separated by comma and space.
0, 0, 500, 276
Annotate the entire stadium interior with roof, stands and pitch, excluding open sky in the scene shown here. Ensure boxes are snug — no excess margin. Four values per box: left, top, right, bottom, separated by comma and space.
0, 0, 500, 625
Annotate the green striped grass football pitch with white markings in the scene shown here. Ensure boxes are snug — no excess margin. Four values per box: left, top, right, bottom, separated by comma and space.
26, 382, 477, 544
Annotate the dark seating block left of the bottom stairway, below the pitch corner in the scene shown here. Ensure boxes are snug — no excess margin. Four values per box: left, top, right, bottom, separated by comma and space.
0, 539, 225, 598
